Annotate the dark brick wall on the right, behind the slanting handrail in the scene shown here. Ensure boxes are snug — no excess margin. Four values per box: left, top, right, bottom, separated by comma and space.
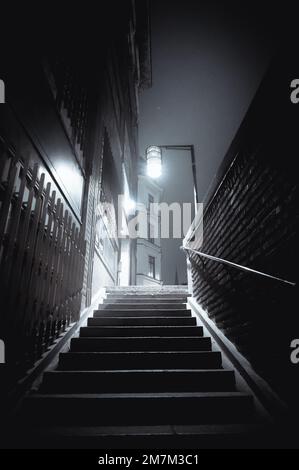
191, 49, 299, 402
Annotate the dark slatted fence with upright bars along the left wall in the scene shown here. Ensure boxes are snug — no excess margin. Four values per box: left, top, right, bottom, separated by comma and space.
0, 140, 86, 371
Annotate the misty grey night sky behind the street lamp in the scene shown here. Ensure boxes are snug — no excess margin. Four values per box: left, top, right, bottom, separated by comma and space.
139, 0, 275, 284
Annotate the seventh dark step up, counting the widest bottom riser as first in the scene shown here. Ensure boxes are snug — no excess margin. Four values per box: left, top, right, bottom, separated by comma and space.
93, 307, 191, 318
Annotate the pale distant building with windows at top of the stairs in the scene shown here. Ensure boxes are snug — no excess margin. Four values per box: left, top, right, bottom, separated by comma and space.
136, 165, 162, 286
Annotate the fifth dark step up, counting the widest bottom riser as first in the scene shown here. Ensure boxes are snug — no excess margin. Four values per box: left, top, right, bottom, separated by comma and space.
80, 325, 203, 338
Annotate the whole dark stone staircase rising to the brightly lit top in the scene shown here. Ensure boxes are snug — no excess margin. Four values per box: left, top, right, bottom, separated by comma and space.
21, 286, 264, 448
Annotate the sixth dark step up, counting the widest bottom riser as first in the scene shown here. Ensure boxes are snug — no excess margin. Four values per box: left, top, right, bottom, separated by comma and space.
87, 317, 196, 326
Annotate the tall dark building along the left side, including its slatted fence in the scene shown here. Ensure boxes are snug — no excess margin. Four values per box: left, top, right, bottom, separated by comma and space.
0, 0, 151, 376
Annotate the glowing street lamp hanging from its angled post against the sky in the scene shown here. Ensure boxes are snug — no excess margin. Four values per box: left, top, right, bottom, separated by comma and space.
146, 145, 199, 211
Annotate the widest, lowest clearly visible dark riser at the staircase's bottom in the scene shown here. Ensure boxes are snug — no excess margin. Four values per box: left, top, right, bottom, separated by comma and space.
22, 392, 254, 426
